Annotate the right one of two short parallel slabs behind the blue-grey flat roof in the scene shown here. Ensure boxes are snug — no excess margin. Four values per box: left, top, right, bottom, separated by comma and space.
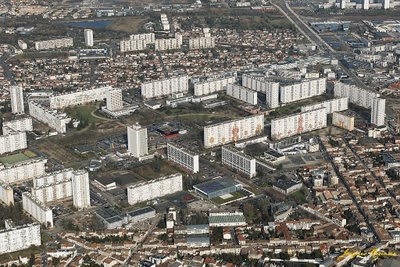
222, 146, 257, 178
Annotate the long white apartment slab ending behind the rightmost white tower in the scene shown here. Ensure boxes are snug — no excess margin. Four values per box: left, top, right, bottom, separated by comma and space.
334, 82, 379, 108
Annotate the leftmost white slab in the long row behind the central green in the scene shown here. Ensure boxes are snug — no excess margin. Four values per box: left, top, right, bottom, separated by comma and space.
141, 75, 189, 99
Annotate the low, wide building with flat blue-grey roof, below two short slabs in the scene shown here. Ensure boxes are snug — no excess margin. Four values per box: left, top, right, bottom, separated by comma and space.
193, 178, 243, 199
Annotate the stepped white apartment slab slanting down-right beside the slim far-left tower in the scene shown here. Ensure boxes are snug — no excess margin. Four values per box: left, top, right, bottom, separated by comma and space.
28, 101, 71, 133
